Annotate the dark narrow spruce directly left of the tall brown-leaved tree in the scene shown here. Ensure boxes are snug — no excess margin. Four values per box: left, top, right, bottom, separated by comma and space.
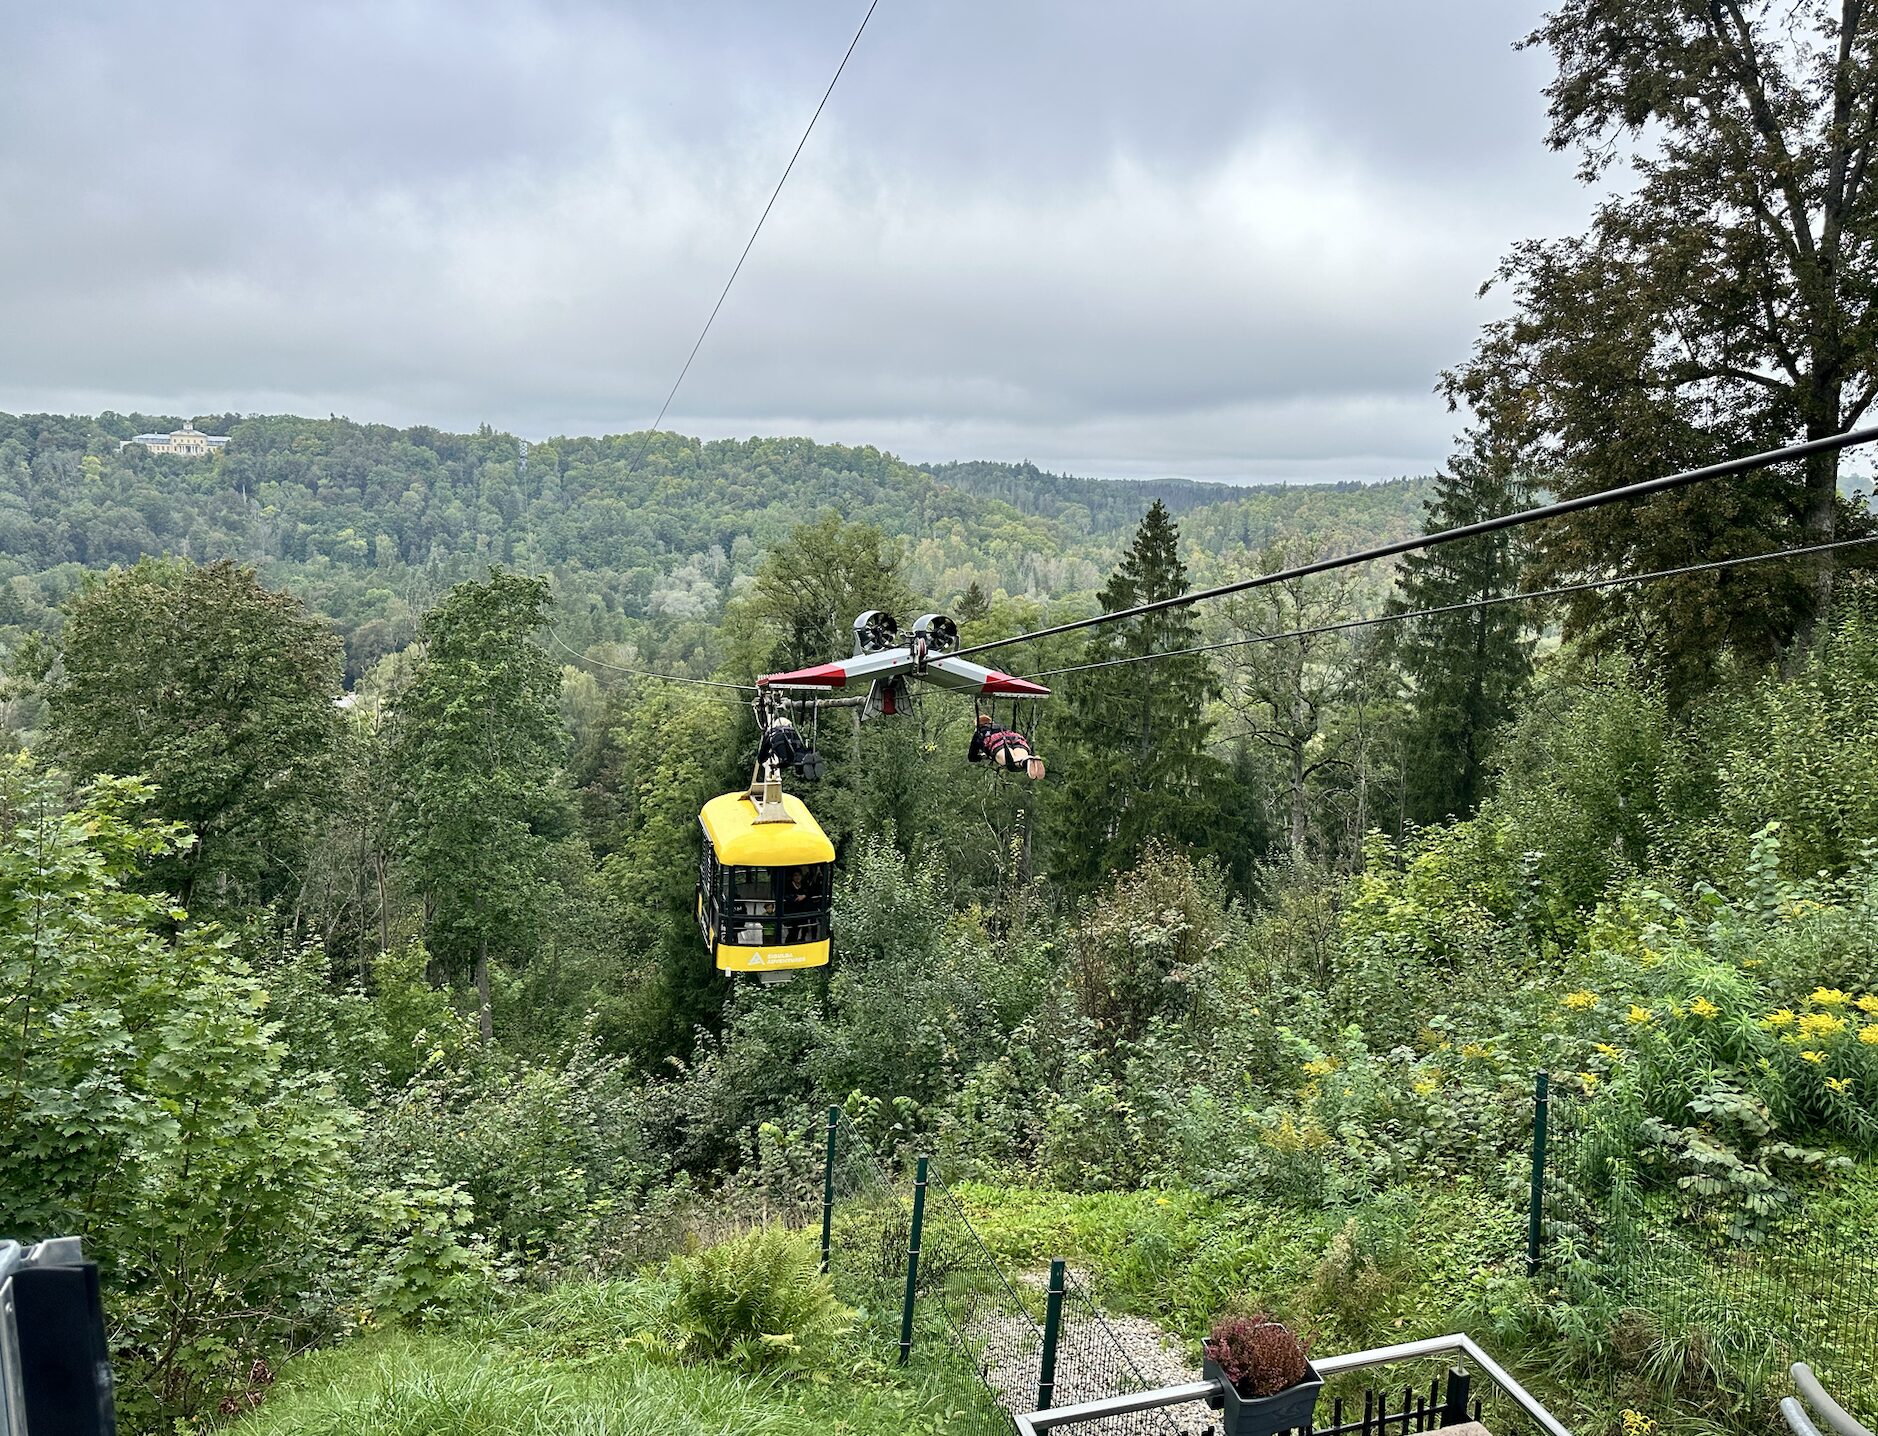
1388, 432, 1532, 822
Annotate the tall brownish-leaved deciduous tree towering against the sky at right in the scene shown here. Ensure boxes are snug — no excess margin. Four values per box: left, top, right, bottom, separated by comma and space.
1448, 0, 1878, 693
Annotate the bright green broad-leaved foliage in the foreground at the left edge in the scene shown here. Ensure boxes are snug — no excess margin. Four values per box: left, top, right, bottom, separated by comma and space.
0, 756, 349, 1421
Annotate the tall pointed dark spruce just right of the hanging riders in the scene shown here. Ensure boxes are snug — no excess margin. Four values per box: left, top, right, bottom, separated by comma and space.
1055, 499, 1223, 886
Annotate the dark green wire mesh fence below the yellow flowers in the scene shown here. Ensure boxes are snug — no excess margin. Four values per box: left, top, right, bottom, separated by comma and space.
1542, 1092, 1878, 1425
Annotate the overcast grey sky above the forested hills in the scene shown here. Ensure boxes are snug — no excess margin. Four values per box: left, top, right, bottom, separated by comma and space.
0, 0, 1589, 479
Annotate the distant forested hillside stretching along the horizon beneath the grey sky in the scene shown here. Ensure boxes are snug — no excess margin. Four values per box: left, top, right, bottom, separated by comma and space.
0, 413, 1425, 676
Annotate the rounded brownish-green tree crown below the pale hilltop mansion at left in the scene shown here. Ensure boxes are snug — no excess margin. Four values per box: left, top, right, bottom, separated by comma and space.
47, 559, 340, 909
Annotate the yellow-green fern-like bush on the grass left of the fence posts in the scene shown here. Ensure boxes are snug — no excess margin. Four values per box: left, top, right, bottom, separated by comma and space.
648, 1228, 854, 1368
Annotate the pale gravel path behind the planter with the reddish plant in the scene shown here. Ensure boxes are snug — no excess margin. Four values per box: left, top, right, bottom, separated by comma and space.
973, 1273, 1219, 1436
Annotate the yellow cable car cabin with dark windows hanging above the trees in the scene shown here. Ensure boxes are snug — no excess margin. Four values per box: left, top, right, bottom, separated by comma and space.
697, 777, 834, 984
